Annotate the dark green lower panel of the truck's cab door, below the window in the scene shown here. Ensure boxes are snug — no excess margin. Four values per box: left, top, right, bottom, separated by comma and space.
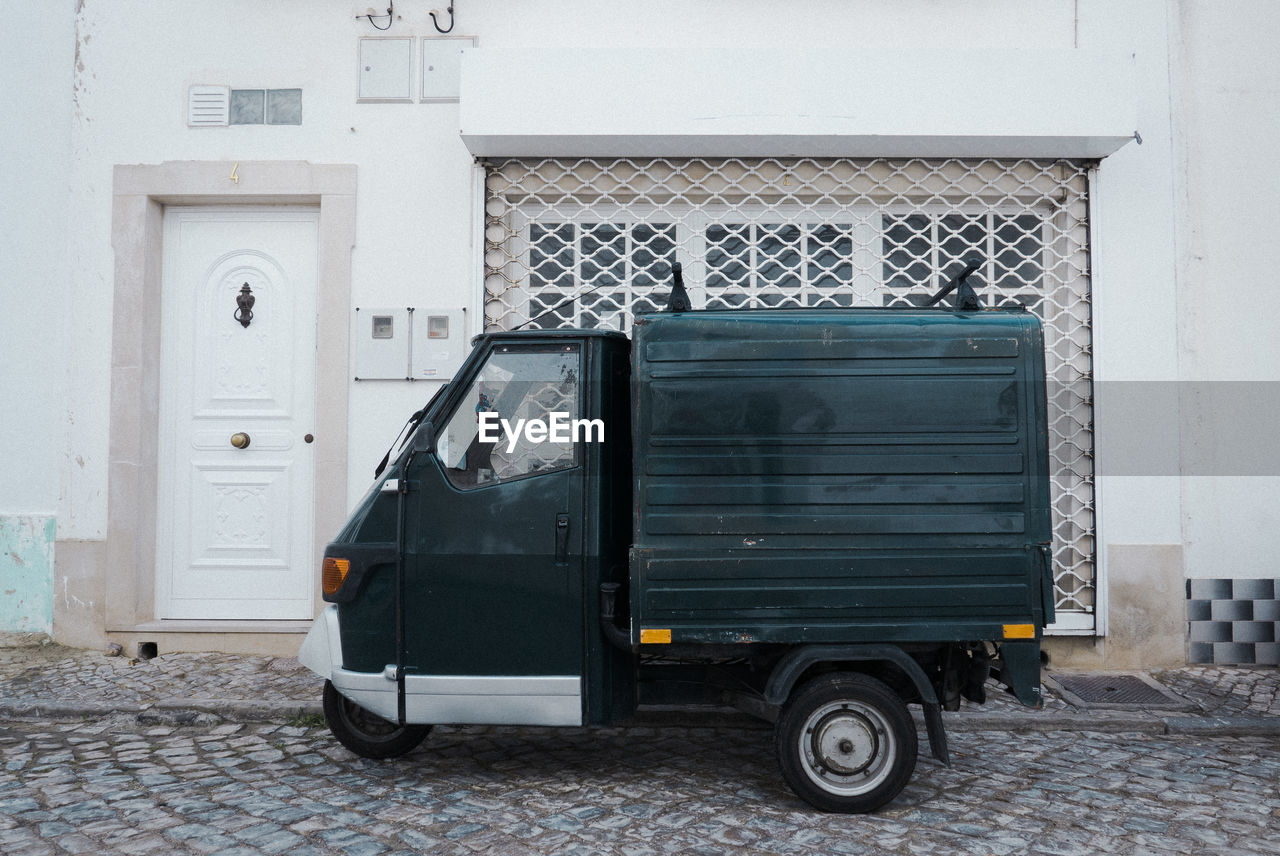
404, 456, 582, 674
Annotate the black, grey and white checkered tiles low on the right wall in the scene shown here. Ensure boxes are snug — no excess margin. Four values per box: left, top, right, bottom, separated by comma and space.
1187, 580, 1280, 665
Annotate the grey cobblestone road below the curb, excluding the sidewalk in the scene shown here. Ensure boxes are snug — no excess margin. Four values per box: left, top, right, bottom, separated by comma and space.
0, 719, 1280, 856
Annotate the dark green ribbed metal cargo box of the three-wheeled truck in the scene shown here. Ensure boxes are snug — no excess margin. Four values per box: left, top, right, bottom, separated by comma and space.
632, 310, 1050, 641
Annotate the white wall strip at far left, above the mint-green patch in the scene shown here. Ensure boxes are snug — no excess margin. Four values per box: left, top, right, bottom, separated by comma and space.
0, 0, 76, 516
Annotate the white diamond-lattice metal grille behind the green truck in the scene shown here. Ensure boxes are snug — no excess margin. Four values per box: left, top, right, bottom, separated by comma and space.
485, 159, 1096, 628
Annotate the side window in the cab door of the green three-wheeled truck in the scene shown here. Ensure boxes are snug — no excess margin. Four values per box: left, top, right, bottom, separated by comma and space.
435, 344, 580, 487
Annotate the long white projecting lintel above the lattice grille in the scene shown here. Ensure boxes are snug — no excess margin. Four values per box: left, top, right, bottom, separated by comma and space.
460, 47, 1140, 159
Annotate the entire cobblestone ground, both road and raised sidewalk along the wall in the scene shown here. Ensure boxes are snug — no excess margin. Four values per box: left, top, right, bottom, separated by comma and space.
0, 645, 1280, 856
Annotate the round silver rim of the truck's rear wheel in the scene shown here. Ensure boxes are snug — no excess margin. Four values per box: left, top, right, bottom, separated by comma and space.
799, 701, 899, 796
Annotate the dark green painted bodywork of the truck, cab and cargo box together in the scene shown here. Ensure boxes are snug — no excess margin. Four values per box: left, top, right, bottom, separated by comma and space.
334, 310, 1052, 723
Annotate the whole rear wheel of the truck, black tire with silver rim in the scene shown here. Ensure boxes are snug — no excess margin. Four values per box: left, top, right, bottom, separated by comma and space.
773, 672, 919, 812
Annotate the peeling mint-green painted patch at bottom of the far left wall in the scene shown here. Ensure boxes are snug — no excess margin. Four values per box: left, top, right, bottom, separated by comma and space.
0, 516, 58, 633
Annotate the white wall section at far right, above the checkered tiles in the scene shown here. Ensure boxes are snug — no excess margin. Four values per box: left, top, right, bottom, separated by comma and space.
1172, 0, 1280, 578
